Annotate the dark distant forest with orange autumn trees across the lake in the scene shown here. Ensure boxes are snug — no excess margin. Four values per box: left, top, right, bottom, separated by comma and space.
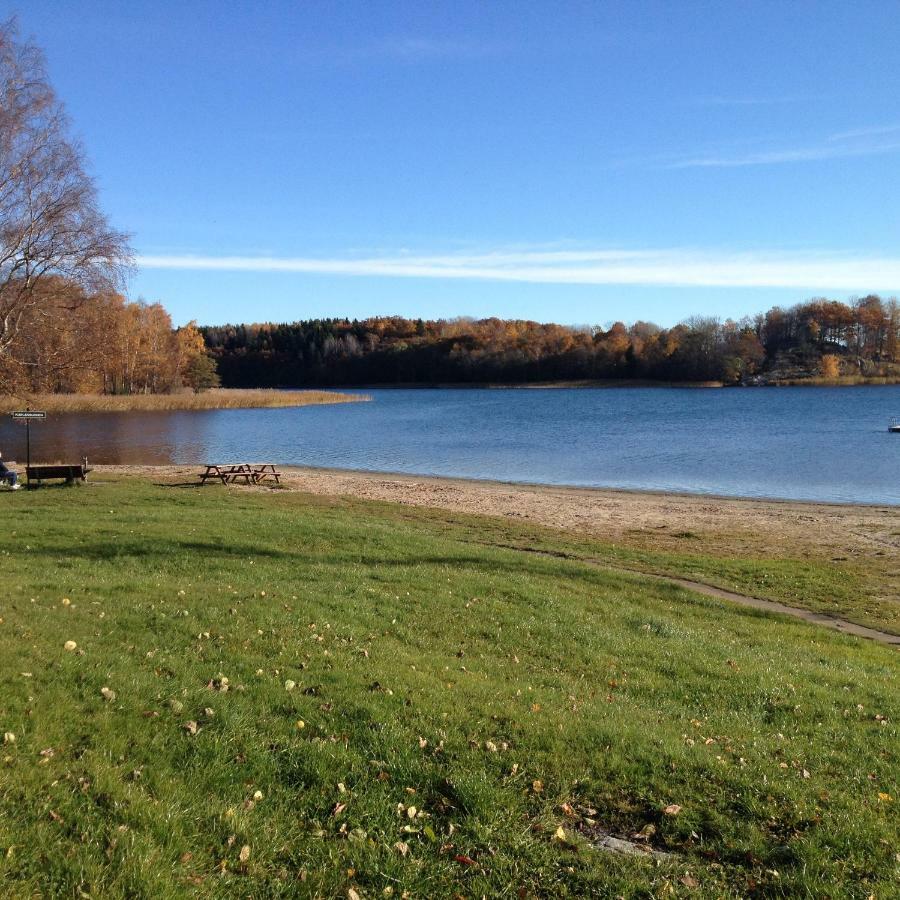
200, 295, 900, 387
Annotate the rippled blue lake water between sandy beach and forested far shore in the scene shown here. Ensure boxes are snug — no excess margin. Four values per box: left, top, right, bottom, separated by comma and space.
0, 386, 900, 504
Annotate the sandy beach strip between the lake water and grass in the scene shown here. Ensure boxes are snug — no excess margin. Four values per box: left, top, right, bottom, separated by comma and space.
95, 465, 900, 575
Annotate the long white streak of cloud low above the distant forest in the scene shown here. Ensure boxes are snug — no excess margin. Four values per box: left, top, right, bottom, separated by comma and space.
138, 248, 900, 292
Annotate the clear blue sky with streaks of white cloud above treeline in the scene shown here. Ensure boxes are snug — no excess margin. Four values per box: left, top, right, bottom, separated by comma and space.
7, 0, 900, 325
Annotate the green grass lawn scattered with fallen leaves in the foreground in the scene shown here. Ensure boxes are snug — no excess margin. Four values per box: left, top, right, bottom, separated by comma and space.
0, 480, 900, 898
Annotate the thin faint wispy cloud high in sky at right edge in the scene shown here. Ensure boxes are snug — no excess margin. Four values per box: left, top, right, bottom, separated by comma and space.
665, 125, 900, 169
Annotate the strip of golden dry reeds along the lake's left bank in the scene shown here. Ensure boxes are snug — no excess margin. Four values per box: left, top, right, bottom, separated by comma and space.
0, 389, 369, 413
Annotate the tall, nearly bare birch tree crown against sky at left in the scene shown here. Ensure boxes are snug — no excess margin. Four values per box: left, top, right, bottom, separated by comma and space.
0, 20, 130, 362
